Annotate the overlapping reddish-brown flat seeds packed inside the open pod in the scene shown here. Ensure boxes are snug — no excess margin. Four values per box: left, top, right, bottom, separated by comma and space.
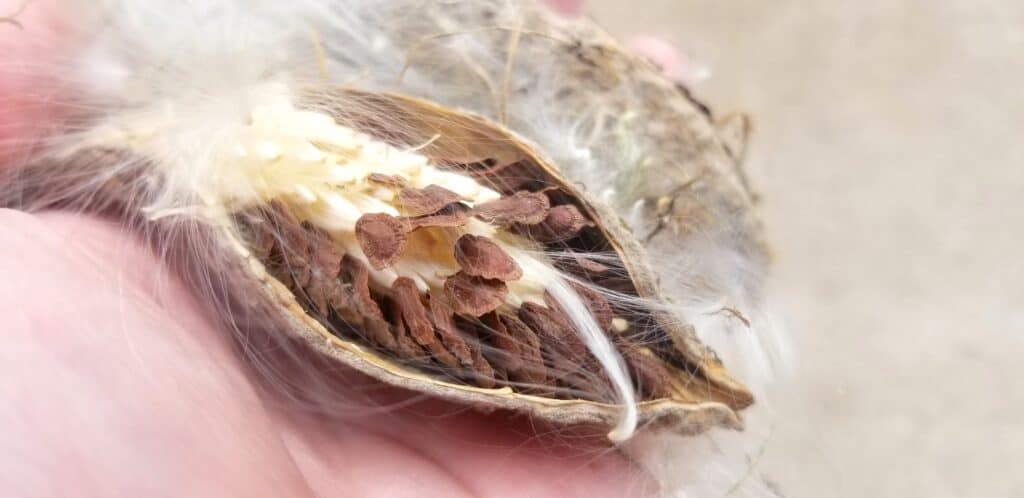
239, 183, 643, 393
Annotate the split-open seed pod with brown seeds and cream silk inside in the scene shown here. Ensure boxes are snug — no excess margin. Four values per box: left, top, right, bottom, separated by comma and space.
190, 88, 753, 438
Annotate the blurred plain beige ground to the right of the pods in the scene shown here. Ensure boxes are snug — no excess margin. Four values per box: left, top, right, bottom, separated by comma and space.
587, 0, 1024, 498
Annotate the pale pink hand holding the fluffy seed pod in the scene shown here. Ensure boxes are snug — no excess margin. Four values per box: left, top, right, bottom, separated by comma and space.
0, 0, 688, 497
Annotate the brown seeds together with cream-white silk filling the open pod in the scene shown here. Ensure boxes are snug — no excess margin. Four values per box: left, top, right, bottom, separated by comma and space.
237, 100, 674, 398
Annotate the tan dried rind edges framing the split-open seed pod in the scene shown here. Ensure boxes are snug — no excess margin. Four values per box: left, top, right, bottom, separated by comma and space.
209, 88, 753, 433
